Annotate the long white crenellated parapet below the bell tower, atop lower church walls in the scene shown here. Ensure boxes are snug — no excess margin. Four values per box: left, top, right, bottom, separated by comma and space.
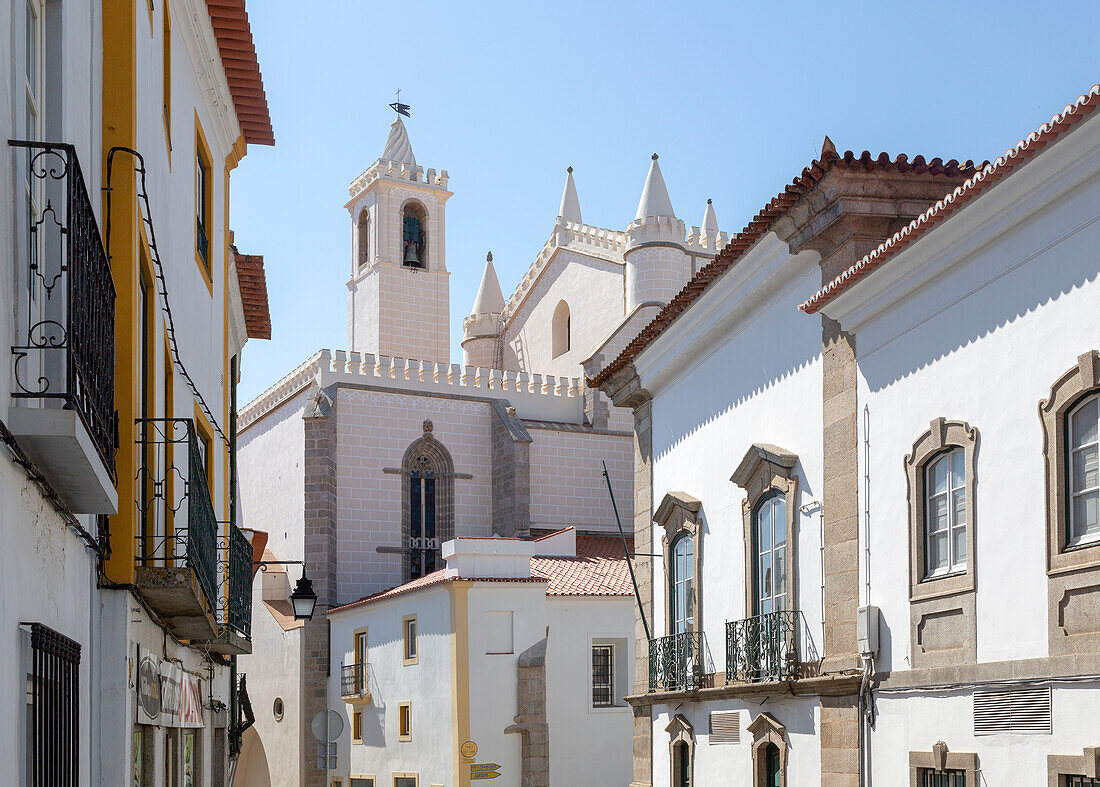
238, 350, 584, 430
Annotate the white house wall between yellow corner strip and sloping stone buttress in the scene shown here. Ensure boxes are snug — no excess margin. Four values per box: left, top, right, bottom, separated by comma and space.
469, 582, 553, 785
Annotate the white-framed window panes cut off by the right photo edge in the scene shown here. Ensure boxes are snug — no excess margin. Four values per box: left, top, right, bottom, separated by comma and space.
1066, 394, 1100, 547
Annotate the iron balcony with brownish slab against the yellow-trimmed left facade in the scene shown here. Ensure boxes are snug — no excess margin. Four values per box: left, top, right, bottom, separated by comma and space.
134, 418, 218, 641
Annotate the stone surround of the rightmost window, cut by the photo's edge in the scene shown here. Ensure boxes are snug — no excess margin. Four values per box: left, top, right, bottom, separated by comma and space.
1038, 350, 1100, 575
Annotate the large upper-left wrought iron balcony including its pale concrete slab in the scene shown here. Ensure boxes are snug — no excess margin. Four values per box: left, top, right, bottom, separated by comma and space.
9, 140, 118, 514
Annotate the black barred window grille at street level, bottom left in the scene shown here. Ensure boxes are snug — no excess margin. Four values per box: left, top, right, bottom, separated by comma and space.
28, 623, 80, 787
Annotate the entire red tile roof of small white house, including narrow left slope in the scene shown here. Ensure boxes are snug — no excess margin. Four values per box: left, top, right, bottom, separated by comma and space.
326, 536, 634, 614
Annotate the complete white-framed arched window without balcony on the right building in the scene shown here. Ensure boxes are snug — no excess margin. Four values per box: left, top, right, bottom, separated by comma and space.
924, 448, 967, 578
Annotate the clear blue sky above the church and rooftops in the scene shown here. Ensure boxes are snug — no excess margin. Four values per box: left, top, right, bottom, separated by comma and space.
231, 0, 1100, 403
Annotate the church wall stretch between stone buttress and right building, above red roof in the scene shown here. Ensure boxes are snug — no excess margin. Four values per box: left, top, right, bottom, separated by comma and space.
527, 424, 634, 533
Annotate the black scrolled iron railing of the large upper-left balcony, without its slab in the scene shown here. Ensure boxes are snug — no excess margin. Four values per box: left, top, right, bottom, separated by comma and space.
8, 140, 118, 481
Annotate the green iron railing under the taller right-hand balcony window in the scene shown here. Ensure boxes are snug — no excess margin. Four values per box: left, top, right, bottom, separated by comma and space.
726, 610, 799, 684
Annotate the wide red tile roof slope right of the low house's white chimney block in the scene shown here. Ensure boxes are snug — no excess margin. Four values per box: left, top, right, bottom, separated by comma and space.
531, 536, 634, 595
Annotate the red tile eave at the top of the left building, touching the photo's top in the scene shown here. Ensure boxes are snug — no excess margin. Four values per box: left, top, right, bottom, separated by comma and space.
207, 0, 275, 145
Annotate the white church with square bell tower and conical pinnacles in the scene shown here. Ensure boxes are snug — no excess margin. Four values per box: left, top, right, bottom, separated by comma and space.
239, 118, 727, 787
